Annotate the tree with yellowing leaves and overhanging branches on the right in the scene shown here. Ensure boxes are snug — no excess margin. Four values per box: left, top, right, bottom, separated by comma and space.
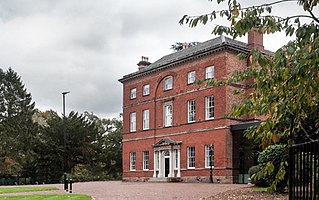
180, 0, 319, 147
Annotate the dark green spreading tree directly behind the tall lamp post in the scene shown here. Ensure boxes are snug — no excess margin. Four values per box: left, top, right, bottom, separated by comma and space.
35, 112, 98, 182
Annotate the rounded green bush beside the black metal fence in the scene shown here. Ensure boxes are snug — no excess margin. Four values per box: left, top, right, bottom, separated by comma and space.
253, 144, 289, 192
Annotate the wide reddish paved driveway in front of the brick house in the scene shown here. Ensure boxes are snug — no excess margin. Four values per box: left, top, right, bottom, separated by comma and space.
0, 181, 249, 200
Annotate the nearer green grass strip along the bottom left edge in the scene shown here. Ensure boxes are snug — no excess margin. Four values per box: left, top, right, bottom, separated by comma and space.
0, 194, 92, 200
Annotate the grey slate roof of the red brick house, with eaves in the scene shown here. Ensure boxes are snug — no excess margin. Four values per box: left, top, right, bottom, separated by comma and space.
119, 36, 272, 83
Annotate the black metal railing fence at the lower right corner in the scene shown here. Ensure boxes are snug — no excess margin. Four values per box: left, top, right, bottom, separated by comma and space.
289, 140, 319, 200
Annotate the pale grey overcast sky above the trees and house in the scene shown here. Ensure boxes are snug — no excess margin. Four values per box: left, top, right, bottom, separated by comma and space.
0, 0, 312, 117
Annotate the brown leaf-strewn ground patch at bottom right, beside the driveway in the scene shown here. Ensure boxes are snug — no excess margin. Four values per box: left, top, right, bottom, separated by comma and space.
203, 188, 288, 200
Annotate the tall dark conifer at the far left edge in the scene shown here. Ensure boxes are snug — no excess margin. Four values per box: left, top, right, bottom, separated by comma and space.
0, 68, 37, 174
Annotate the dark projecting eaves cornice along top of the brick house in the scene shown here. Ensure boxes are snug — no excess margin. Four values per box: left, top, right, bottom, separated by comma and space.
118, 42, 250, 83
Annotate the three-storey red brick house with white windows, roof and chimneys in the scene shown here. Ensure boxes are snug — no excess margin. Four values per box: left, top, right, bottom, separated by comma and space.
119, 32, 263, 183
